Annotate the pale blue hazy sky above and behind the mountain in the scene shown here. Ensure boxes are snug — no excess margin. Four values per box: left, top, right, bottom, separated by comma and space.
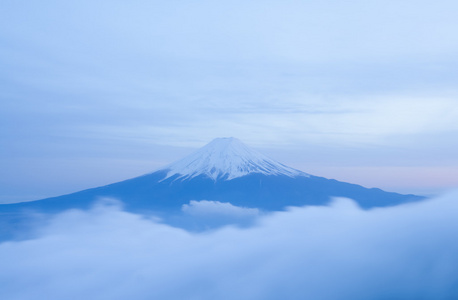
0, 0, 458, 202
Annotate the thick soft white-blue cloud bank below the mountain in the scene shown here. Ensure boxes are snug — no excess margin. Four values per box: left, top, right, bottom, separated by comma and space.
0, 192, 458, 300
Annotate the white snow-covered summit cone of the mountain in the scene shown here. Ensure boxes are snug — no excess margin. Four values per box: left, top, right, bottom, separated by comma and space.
159, 138, 309, 180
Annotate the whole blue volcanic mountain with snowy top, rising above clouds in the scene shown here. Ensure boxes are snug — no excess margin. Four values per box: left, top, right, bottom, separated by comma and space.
0, 138, 423, 221
